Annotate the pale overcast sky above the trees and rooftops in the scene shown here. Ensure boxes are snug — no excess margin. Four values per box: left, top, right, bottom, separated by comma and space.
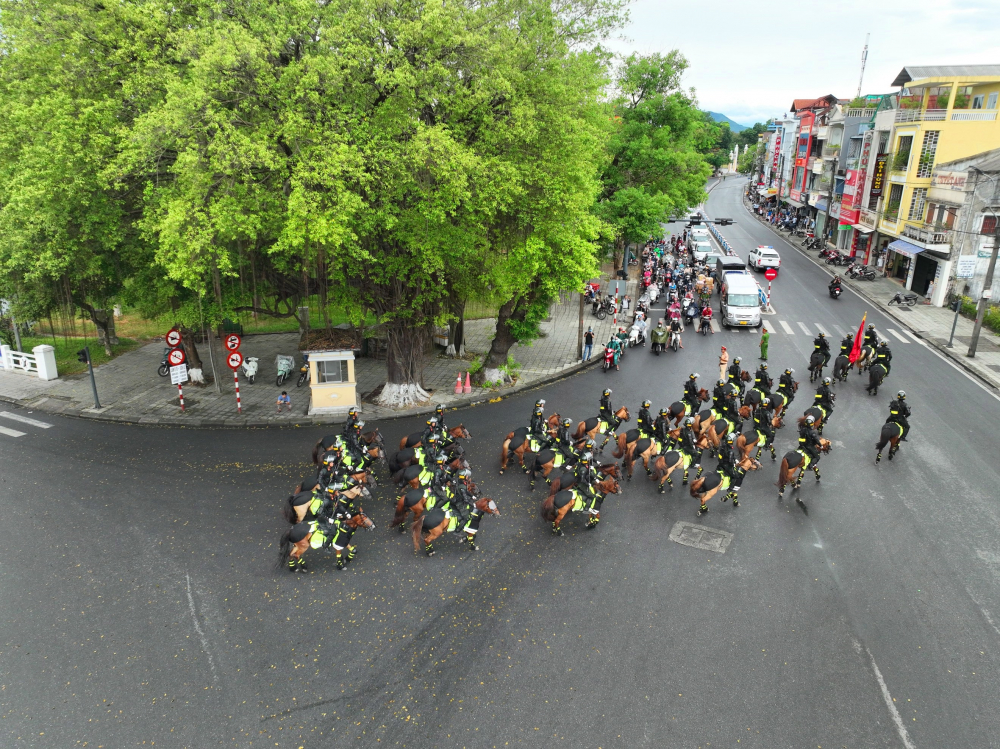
612, 0, 1000, 125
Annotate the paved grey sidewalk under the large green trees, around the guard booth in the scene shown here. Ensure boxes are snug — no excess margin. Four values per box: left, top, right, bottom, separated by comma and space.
0, 270, 637, 427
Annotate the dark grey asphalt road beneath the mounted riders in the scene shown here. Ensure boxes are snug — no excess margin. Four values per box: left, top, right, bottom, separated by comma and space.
0, 180, 1000, 749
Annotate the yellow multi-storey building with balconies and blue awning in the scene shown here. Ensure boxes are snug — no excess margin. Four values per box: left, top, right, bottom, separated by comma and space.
869, 65, 1000, 306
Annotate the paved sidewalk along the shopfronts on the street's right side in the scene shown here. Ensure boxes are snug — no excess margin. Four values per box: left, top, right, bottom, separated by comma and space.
744, 202, 1000, 390
